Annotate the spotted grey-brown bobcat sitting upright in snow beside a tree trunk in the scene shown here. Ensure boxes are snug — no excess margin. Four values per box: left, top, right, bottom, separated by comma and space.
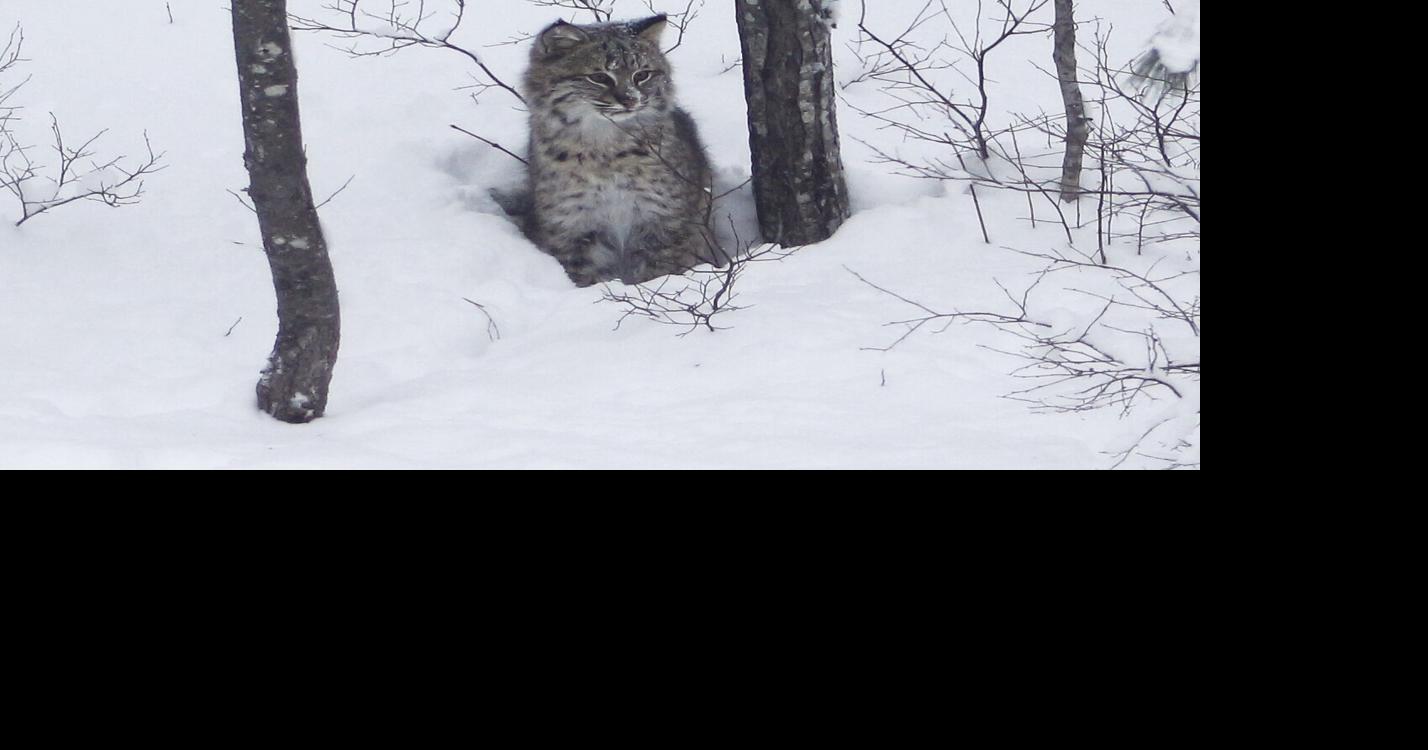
524, 16, 720, 286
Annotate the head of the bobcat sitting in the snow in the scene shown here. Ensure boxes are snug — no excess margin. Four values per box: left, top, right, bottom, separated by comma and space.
526, 16, 674, 124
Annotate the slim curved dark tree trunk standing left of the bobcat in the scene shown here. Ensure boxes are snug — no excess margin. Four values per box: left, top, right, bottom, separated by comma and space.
233, 0, 340, 423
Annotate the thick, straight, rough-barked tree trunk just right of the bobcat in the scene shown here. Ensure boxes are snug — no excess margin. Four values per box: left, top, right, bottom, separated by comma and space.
735, 0, 850, 246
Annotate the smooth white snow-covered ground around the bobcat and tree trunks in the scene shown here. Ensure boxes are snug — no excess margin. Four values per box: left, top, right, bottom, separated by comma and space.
0, 0, 1198, 469
